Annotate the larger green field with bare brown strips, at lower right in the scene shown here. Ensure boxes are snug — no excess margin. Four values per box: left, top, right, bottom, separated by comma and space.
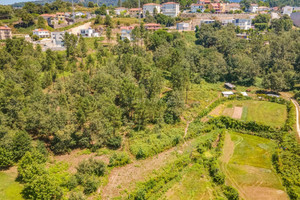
220, 133, 287, 199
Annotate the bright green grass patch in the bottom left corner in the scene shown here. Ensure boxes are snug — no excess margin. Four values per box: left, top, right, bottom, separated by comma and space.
0, 172, 23, 200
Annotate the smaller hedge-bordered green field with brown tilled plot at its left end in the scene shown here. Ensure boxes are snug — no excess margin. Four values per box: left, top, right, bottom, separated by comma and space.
210, 100, 287, 127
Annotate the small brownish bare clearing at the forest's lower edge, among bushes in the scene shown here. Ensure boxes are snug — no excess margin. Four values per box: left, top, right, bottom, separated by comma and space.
53, 149, 109, 173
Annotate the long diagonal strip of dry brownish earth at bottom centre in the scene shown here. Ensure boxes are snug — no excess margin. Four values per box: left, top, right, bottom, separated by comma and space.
101, 145, 190, 199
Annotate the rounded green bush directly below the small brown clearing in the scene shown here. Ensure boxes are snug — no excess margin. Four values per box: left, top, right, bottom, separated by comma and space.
77, 158, 106, 176
